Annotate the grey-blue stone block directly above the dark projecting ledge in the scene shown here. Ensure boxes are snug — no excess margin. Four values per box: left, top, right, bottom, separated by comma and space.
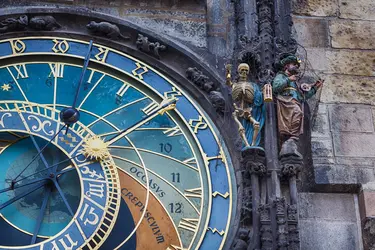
314, 164, 375, 185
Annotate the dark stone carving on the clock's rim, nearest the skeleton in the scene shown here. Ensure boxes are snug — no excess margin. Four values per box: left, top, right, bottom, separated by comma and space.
186, 67, 225, 114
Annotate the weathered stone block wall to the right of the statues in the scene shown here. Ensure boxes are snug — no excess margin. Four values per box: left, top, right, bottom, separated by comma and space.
293, 0, 375, 249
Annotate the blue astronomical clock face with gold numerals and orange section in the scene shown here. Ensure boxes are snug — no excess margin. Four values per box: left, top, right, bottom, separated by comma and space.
0, 37, 236, 250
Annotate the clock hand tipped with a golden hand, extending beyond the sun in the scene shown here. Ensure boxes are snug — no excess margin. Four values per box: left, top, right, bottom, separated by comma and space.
105, 98, 177, 145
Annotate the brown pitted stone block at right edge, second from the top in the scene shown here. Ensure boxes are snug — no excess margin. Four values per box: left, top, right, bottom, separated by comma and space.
329, 20, 375, 49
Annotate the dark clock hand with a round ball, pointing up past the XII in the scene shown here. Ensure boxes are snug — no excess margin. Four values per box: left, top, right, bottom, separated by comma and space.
60, 40, 93, 134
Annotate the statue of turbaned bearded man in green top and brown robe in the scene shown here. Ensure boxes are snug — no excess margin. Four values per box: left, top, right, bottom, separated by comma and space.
272, 55, 322, 158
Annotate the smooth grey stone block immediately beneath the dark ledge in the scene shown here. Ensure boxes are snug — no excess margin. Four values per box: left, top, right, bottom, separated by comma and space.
298, 193, 357, 222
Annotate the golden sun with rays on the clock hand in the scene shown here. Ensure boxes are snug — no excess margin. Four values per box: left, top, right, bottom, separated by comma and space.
83, 135, 109, 160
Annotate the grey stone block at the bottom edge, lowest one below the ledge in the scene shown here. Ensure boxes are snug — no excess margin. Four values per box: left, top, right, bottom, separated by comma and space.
299, 220, 360, 250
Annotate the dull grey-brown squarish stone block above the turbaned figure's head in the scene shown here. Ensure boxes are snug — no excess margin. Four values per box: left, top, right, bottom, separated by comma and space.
293, 17, 329, 47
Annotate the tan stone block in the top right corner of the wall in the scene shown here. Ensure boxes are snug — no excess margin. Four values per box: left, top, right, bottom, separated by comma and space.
339, 0, 375, 20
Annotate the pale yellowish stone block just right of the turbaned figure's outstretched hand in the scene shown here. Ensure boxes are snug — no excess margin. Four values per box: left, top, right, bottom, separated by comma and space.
321, 74, 375, 105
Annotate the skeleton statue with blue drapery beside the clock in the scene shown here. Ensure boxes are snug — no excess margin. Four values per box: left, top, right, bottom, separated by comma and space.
226, 63, 265, 148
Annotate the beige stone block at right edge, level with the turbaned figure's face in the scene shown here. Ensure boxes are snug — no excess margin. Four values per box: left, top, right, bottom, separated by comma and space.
321, 49, 375, 76
